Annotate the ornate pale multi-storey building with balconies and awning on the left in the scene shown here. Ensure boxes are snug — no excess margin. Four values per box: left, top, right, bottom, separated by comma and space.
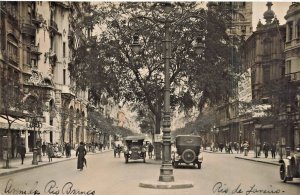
0, 1, 88, 158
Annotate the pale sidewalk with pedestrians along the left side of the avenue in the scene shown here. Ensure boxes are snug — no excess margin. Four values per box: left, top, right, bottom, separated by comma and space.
0, 149, 112, 177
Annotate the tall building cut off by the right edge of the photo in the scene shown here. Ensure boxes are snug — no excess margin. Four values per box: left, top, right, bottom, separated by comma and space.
282, 2, 300, 148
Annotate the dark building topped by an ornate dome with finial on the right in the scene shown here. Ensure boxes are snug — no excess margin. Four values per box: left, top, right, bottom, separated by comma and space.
240, 2, 285, 146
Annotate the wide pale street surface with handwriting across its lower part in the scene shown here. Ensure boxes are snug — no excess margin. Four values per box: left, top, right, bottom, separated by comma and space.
0, 151, 300, 195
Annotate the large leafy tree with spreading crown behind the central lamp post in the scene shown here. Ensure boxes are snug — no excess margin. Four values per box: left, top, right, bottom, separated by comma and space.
70, 2, 239, 136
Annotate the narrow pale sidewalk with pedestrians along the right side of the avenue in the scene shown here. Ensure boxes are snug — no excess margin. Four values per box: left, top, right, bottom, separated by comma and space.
204, 150, 279, 166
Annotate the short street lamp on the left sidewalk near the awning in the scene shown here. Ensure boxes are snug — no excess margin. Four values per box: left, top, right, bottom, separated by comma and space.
25, 115, 44, 165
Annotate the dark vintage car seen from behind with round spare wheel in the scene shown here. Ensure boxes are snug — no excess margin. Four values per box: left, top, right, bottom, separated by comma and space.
172, 135, 203, 169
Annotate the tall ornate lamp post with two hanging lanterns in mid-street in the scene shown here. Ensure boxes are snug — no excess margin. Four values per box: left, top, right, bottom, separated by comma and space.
131, 2, 204, 182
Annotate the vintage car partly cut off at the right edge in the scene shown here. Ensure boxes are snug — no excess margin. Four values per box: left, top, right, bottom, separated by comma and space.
279, 146, 300, 182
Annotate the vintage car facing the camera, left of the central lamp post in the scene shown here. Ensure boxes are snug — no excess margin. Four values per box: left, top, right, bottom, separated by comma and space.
124, 136, 146, 163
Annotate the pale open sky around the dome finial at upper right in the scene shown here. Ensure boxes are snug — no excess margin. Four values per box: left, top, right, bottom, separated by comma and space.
252, 1, 292, 31
